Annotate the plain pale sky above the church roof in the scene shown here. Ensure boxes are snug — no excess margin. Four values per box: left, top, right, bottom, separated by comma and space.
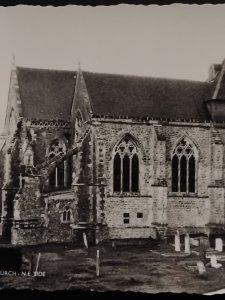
0, 4, 225, 131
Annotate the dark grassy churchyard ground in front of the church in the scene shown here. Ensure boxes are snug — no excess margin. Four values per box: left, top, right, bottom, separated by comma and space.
0, 244, 225, 294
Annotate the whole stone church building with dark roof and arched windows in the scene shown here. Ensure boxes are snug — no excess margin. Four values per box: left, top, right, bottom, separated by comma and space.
0, 61, 225, 245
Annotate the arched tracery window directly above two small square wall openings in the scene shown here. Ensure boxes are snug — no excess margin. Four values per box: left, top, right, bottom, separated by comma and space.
113, 137, 139, 193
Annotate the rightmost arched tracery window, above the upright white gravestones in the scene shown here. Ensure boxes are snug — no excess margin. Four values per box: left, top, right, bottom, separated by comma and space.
172, 138, 196, 193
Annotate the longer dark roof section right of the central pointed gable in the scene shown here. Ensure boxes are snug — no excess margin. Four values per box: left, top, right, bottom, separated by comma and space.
83, 72, 213, 120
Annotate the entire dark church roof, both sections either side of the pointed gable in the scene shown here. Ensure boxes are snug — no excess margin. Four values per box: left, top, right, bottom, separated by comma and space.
17, 67, 214, 120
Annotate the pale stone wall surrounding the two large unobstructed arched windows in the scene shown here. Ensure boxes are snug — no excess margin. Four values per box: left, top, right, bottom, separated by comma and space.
93, 120, 224, 237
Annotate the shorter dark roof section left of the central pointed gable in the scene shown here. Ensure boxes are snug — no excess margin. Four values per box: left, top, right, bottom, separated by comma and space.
17, 67, 76, 120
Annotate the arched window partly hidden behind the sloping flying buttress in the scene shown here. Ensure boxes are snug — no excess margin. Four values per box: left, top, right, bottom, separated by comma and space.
48, 140, 65, 187
